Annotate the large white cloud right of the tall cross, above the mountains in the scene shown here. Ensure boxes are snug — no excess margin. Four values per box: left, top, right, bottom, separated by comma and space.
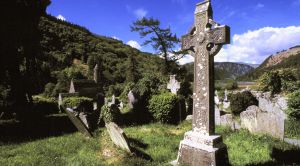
215, 26, 300, 64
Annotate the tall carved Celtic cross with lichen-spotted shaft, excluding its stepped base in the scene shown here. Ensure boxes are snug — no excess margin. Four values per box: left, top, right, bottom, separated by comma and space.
182, 0, 230, 135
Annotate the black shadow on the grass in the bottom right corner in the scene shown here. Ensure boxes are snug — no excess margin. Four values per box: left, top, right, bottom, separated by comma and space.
249, 148, 300, 166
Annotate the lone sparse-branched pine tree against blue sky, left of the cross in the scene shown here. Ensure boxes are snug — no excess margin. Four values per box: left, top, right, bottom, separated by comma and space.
131, 17, 182, 72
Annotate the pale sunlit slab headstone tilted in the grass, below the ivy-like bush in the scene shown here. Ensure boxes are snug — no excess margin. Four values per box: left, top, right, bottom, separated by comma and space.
105, 122, 131, 153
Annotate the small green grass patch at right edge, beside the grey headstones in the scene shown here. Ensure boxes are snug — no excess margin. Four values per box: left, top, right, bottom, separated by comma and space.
284, 120, 300, 139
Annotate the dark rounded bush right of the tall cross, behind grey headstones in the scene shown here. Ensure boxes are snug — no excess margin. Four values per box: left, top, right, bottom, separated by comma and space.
229, 91, 258, 116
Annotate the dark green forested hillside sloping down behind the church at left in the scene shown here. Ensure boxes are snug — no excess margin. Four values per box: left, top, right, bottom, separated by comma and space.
38, 15, 175, 96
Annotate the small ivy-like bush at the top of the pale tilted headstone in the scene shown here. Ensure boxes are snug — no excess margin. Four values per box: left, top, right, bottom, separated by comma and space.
99, 104, 122, 124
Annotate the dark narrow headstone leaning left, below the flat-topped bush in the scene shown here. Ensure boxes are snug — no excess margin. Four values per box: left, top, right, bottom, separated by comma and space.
65, 108, 92, 137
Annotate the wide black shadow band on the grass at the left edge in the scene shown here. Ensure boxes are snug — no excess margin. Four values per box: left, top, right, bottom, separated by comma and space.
0, 114, 77, 144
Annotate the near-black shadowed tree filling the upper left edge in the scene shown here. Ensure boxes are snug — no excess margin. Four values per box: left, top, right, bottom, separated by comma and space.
0, 0, 50, 115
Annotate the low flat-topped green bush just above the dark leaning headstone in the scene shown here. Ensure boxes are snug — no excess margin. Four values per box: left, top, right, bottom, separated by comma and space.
62, 97, 93, 112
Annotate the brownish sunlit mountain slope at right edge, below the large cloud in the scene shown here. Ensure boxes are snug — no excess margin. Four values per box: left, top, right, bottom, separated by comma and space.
239, 46, 300, 81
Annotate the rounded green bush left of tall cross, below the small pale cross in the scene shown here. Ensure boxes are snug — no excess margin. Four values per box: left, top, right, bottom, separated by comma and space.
148, 92, 186, 123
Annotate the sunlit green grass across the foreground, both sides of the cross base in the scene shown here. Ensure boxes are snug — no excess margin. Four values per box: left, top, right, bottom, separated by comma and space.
0, 121, 300, 166
